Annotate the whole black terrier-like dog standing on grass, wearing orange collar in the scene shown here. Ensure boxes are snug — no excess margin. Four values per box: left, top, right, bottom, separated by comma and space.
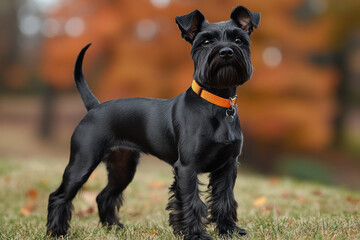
47, 6, 260, 239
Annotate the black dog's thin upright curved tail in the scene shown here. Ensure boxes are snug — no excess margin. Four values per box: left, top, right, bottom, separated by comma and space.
74, 43, 100, 111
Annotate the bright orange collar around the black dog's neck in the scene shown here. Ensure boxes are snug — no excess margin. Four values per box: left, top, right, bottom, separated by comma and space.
191, 80, 237, 108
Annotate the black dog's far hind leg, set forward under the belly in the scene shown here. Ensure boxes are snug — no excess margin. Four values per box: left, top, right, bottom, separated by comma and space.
96, 149, 140, 228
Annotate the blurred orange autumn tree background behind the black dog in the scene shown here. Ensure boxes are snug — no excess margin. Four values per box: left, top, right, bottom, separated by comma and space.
0, 0, 360, 189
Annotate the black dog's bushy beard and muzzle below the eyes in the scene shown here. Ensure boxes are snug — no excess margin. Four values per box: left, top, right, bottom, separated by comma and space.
205, 49, 252, 89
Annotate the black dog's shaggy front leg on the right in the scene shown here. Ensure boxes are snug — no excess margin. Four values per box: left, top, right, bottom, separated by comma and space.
209, 159, 246, 235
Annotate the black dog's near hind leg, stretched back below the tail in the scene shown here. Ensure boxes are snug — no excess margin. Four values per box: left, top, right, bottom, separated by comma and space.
46, 131, 103, 237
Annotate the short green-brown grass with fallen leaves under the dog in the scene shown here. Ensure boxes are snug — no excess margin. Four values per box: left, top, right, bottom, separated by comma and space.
0, 156, 360, 239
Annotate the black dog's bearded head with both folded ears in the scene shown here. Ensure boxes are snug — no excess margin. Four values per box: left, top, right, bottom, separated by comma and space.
175, 6, 260, 88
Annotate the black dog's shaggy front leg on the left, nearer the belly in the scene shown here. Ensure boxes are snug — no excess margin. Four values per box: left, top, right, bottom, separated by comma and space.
167, 161, 212, 240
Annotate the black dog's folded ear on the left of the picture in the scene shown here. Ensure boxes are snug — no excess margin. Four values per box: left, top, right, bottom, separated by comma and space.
175, 10, 205, 44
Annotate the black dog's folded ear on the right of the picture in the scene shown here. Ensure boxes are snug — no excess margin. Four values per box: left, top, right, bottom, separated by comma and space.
230, 6, 260, 35
